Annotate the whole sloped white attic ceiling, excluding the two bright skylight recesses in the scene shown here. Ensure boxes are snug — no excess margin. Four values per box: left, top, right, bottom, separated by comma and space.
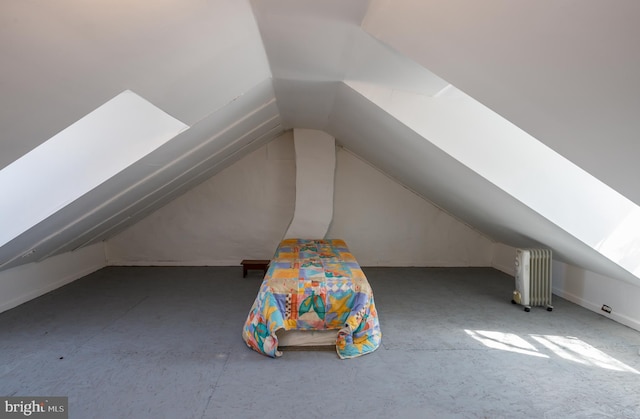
0, 0, 640, 281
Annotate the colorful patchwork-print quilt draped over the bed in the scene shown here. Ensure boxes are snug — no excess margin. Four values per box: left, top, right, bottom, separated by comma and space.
242, 239, 382, 359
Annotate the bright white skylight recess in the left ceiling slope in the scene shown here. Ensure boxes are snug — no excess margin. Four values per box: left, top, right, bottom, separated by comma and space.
0, 90, 188, 252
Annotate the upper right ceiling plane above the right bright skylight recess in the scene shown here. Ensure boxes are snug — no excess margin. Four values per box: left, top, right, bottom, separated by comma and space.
362, 0, 640, 204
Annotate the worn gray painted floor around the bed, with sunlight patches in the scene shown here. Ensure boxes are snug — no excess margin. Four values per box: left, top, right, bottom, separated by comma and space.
0, 267, 640, 418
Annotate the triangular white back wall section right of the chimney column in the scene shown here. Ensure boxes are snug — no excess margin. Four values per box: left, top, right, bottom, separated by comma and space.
327, 148, 493, 266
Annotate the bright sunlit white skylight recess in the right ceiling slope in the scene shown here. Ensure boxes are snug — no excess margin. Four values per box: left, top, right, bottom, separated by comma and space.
345, 78, 640, 278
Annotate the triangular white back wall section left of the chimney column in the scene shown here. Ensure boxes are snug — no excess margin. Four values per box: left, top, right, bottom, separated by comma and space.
106, 131, 295, 266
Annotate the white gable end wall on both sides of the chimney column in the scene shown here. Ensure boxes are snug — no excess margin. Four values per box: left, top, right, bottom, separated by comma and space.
106, 132, 493, 266
